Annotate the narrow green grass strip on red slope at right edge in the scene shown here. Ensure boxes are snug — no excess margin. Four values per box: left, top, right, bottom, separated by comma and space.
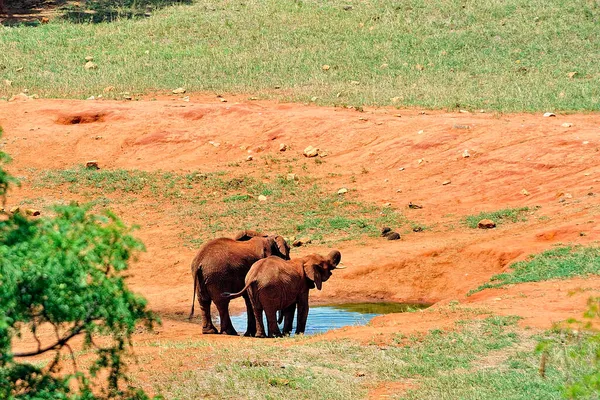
469, 246, 600, 295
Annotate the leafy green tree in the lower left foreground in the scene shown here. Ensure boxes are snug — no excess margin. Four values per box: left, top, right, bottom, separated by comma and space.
0, 130, 158, 399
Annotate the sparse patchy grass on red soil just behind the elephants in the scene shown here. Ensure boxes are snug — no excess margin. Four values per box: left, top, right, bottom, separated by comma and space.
31, 168, 408, 247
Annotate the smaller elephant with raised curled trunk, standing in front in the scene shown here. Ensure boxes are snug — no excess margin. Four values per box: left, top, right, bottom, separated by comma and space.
221, 250, 342, 337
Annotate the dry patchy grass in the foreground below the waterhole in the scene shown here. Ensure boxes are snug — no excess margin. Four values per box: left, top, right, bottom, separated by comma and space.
138, 316, 598, 400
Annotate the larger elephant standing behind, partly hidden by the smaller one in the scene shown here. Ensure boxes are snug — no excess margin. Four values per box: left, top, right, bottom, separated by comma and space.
189, 231, 290, 336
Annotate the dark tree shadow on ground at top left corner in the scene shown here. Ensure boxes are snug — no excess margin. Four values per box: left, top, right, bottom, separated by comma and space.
0, 0, 193, 26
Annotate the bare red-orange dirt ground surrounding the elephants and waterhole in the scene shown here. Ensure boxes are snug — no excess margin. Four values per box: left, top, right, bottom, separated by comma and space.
0, 95, 600, 354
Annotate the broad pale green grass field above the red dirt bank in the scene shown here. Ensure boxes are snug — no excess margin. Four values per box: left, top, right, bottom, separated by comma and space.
0, 0, 600, 111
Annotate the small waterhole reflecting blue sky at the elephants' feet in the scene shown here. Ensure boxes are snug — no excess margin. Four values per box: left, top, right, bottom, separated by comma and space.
226, 303, 430, 335
